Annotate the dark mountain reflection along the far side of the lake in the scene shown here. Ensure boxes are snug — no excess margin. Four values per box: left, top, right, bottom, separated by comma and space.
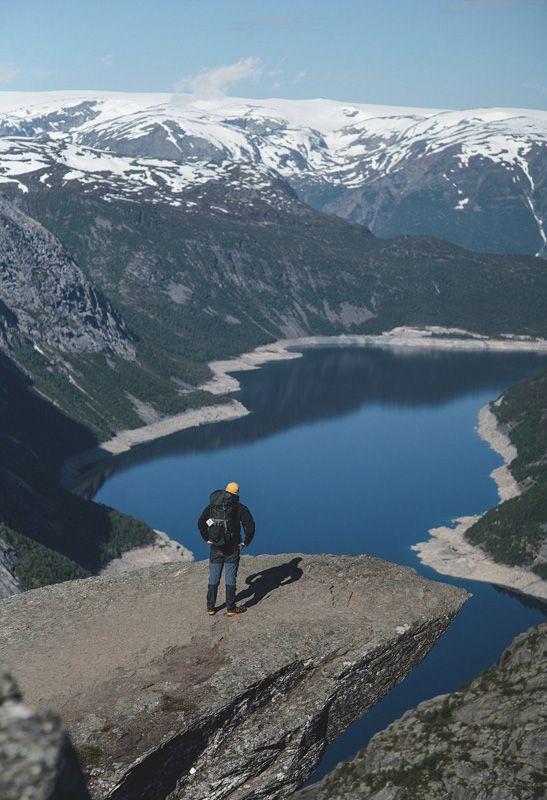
86, 347, 546, 497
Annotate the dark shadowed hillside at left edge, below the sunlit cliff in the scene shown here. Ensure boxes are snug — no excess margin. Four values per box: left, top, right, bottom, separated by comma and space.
0, 353, 153, 589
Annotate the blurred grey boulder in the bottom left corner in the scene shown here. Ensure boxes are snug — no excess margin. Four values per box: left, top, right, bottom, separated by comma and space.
0, 670, 89, 800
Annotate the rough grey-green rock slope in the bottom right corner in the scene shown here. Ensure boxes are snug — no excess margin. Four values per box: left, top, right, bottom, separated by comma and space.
295, 623, 547, 800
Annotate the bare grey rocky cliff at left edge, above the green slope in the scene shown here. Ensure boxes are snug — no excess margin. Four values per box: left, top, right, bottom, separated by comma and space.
0, 197, 134, 358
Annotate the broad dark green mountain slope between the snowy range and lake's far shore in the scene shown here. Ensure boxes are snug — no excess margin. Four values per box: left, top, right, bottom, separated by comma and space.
27, 184, 547, 366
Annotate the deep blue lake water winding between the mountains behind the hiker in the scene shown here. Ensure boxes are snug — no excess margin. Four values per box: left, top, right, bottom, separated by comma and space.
96, 348, 547, 779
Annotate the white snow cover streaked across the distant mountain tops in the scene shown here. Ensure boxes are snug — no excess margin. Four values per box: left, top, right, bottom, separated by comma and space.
0, 91, 547, 227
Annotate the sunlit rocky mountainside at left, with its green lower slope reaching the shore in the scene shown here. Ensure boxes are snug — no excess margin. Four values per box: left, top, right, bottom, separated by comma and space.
0, 194, 212, 439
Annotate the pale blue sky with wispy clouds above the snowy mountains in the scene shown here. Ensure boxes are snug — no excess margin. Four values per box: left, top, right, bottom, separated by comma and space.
0, 0, 547, 108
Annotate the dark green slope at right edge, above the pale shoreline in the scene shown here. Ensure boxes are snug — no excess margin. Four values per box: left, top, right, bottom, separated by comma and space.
466, 372, 547, 579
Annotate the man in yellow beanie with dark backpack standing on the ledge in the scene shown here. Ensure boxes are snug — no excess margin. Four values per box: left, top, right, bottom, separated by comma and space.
198, 481, 255, 617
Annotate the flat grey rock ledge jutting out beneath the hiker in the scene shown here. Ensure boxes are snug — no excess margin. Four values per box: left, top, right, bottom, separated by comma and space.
0, 555, 466, 800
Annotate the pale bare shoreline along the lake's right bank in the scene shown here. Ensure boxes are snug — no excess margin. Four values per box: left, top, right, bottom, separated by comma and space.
411, 405, 547, 602
